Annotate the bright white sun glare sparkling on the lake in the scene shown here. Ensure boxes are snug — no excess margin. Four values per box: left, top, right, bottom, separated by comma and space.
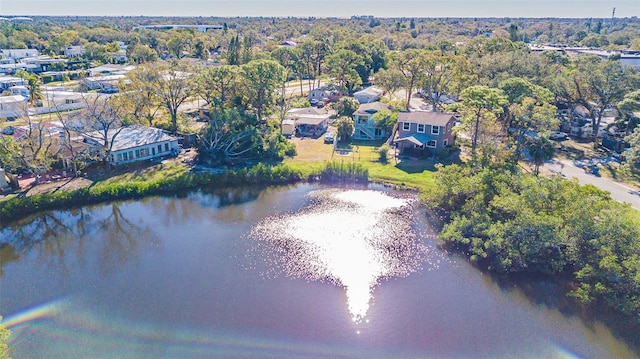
251, 189, 425, 321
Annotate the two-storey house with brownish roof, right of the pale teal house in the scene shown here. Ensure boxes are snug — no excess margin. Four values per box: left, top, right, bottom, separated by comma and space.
393, 111, 456, 155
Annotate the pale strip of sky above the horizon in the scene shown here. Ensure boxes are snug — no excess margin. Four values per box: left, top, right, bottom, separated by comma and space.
0, 0, 640, 19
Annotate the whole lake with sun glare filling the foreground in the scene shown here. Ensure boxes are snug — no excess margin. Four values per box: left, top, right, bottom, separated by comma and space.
0, 184, 637, 358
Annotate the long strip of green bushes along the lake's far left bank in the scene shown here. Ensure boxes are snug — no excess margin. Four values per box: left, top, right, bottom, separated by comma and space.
0, 164, 302, 224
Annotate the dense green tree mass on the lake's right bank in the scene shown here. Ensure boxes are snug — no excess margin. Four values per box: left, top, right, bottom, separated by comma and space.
427, 165, 640, 336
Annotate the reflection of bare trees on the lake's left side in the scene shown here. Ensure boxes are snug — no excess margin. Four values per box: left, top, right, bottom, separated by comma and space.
0, 202, 158, 277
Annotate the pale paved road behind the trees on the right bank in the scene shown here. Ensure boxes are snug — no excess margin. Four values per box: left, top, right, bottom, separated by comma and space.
543, 159, 640, 209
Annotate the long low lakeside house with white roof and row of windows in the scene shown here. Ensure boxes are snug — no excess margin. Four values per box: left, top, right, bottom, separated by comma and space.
84, 125, 180, 164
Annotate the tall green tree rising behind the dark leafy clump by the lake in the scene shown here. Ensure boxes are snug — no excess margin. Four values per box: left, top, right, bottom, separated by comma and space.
240, 60, 285, 121
